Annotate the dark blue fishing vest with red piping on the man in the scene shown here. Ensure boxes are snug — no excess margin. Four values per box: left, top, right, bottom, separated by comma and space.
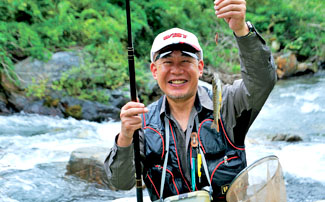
143, 97, 247, 201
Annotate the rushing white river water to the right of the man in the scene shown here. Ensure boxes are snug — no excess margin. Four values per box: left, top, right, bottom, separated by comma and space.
246, 71, 325, 202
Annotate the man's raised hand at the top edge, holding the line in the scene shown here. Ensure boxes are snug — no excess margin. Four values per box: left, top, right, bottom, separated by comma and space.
214, 0, 249, 37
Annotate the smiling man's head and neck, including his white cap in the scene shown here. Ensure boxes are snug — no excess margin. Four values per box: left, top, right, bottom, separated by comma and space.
150, 36, 204, 131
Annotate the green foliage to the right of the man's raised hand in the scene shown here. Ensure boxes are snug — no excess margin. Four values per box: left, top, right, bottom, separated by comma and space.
247, 0, 325, 59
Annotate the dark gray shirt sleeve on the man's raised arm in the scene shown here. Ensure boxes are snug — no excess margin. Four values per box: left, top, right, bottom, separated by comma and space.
222, 32, 276, 145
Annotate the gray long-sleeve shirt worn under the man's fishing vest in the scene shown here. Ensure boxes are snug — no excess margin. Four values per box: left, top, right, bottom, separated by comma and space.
105, 29, 276, 190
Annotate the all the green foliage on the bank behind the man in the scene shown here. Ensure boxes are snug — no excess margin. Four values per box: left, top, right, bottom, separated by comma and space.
0, 0, 325, 102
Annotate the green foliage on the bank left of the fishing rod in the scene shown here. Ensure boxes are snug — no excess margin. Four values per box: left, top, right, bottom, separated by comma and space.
0, 0, 133, 102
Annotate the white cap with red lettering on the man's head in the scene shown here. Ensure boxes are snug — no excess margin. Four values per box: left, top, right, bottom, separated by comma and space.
150, 28, 203, 62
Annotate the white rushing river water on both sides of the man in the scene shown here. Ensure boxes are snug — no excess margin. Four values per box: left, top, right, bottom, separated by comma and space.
0, 72, 325, 202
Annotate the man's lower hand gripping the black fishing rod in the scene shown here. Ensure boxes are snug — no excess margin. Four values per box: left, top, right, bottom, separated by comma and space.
117, 101, 148, 147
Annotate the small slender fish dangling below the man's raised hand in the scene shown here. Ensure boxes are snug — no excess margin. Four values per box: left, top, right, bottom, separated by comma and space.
211, 73, 222, 132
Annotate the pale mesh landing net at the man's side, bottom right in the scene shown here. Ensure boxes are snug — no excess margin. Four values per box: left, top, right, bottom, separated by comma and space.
226, 156, 287, 202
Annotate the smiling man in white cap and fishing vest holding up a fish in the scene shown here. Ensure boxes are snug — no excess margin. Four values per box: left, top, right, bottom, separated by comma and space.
105, 0, 276, 201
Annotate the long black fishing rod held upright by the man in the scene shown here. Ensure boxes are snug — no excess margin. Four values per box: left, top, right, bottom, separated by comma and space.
126, 0, 143, 202
